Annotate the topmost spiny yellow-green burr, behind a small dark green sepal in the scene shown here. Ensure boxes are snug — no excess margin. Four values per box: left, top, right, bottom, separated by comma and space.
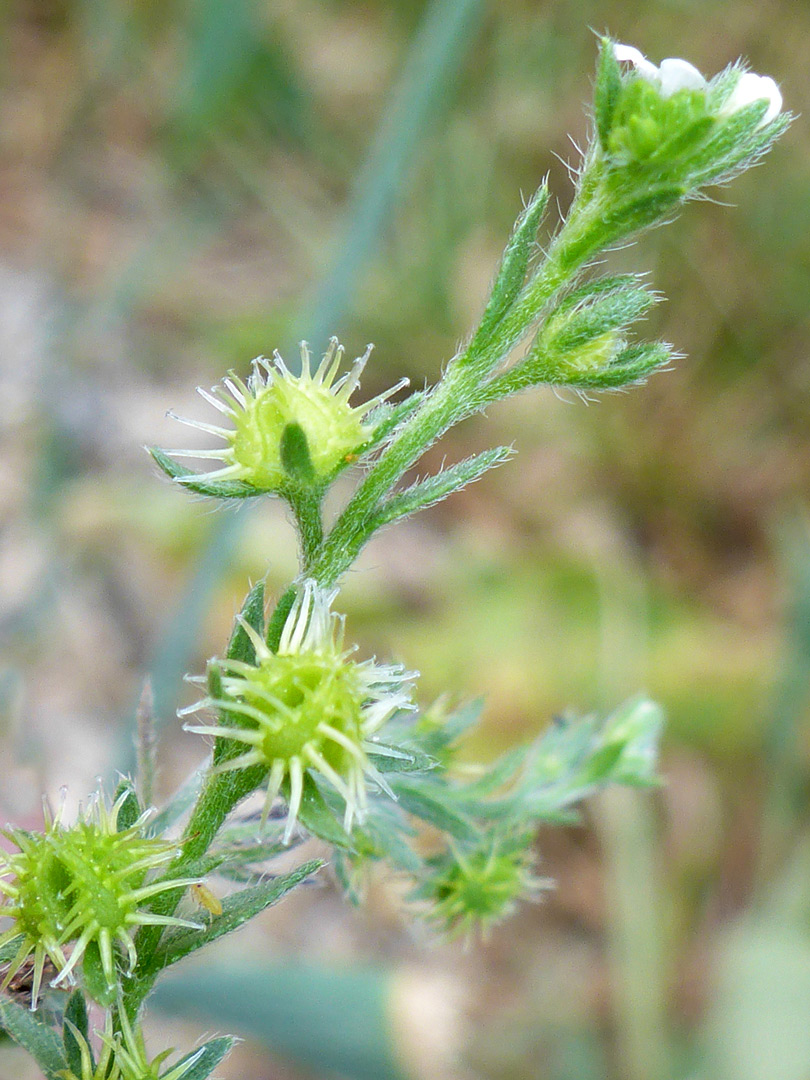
164, 338, 407, 494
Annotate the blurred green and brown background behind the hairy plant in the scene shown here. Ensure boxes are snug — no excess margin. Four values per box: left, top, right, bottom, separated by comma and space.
0, 0, 810, 1080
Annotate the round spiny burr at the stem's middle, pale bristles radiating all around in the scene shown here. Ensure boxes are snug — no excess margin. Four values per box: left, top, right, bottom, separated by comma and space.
181, 581, 415, 843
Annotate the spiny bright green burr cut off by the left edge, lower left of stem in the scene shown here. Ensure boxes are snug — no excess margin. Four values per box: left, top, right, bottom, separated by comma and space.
0, 789, 198, 1005
